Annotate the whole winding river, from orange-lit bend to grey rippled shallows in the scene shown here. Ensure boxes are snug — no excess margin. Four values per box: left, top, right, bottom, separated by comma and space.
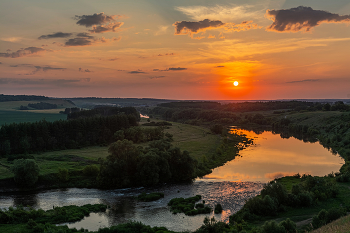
0, 128, 344, 232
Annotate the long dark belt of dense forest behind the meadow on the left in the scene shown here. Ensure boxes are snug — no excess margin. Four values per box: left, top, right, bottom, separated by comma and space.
0, 114, 138, 157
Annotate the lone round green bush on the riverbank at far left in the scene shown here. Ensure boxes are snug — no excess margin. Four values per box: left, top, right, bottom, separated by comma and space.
11, 159, 40, 187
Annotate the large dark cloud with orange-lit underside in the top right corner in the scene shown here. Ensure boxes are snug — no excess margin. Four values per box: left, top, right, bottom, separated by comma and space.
265, 6, 350, 32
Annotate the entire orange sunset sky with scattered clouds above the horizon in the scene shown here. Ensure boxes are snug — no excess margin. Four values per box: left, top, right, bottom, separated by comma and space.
0, 0, 350, 100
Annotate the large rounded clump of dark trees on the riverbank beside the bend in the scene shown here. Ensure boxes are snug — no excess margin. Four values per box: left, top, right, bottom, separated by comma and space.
98, 137, 197, 188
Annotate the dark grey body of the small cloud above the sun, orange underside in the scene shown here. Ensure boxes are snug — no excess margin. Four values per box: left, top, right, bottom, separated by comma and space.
173, 19, 225, 35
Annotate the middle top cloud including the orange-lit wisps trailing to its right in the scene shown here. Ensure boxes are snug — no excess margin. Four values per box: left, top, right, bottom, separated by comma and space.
173, 19, 261, 39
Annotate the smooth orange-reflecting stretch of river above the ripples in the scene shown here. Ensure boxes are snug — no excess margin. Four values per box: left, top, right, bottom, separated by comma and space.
205, 128, 344, 183
